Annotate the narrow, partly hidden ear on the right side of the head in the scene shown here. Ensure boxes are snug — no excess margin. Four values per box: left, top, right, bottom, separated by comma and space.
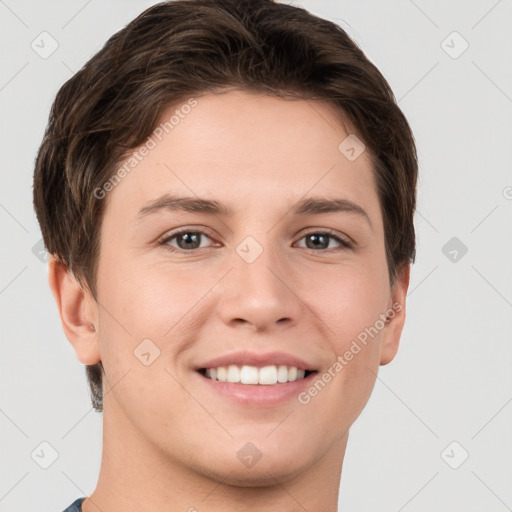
380, 263, 411, 365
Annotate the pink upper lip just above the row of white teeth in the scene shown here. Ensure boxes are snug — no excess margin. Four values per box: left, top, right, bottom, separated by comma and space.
195, 351, 315, 371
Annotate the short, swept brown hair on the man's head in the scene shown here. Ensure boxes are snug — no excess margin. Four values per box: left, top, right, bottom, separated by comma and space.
34, 0, 418, 411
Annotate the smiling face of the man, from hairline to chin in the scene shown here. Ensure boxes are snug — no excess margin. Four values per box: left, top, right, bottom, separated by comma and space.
82, 91, 406, 485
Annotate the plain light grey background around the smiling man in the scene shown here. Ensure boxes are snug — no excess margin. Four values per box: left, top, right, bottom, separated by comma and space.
0, 0, 512, 512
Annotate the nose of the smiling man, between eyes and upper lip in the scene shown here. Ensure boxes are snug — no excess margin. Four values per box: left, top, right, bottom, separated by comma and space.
218, 242, 305, 332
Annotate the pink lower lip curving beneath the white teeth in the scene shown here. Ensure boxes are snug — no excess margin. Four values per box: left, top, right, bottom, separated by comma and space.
194, 371, 317, 407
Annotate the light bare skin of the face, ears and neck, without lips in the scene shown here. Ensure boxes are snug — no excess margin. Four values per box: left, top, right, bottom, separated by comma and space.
49, 91, 409, 512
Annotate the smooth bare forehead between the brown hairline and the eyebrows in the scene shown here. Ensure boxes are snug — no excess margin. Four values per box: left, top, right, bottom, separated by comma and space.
108, 91, 378, 228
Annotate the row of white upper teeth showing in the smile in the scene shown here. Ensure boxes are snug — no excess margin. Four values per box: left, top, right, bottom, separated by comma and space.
206, 364, 306, 386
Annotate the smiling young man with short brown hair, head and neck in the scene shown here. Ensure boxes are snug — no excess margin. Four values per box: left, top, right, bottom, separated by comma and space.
34, 0, 417, 512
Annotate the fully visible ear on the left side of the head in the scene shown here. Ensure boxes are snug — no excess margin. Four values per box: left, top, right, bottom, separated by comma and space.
48, 255, 101, 365
